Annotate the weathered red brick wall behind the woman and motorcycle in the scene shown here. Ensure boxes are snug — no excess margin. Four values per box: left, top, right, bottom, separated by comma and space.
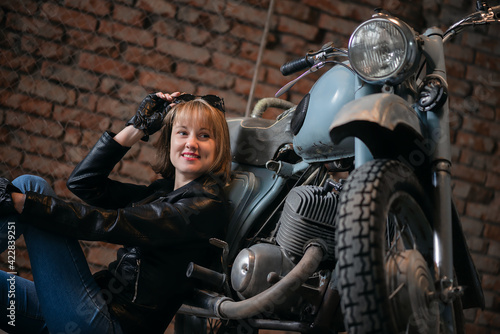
0, 0, 500, 333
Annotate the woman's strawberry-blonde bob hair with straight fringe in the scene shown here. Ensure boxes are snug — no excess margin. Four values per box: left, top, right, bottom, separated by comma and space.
152, 99, 231, 184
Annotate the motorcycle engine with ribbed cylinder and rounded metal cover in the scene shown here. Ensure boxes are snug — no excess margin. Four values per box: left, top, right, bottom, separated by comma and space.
231, 186, 337, 298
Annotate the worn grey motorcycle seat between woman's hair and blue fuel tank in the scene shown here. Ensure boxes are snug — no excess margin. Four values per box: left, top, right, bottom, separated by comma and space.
227, 113, 293, 166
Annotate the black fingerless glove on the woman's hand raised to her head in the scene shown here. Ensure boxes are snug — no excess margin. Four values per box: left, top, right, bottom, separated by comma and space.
127, 94, 170, 141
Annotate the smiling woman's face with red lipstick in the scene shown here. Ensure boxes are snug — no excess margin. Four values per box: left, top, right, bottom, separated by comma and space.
170, 120, 215, 185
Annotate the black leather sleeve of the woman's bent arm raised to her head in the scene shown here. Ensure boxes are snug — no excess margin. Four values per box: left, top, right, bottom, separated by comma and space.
67, 132, 151, 209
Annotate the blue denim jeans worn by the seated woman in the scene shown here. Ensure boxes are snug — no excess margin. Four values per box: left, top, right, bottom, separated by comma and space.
0, 175, 122, 334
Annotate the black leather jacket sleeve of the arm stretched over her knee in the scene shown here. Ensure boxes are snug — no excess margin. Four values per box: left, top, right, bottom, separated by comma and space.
20, 188, 226, 247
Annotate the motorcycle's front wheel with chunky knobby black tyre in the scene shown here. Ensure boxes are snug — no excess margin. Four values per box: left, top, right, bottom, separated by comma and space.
337, 160, 464, 334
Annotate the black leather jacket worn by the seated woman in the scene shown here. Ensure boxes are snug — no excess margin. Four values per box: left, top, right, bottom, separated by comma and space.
21, 132, 227, 333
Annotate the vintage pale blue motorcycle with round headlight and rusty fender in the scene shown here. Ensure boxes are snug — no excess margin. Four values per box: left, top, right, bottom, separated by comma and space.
175, 1, 500, 333
